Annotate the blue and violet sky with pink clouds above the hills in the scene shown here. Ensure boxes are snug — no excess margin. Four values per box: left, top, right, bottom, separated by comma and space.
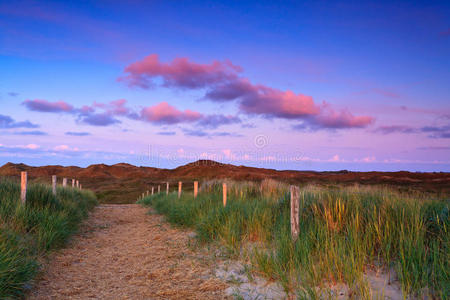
0, 0, 450, 172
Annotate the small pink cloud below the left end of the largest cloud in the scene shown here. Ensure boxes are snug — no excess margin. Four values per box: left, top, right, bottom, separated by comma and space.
140, 102, 203, 124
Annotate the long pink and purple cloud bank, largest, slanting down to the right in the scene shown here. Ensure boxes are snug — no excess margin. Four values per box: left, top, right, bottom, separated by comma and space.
119, 54, 374, 129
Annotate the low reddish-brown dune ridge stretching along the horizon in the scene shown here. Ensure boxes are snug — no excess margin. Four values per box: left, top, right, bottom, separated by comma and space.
0, 160, 450, 203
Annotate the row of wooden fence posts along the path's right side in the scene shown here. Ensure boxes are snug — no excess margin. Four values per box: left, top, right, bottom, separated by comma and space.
142, 181, 300, 241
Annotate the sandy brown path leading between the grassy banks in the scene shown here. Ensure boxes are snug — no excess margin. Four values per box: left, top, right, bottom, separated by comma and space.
28, 205, 227, 299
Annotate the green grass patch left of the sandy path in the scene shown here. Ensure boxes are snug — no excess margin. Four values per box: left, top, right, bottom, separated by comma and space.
0, 178, 97, 299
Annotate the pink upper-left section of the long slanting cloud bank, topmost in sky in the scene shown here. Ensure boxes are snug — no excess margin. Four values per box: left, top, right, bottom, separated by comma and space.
119, 54, 242, 88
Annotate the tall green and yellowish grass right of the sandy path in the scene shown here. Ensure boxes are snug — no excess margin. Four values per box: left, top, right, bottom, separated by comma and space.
139, 181, 450, 299
